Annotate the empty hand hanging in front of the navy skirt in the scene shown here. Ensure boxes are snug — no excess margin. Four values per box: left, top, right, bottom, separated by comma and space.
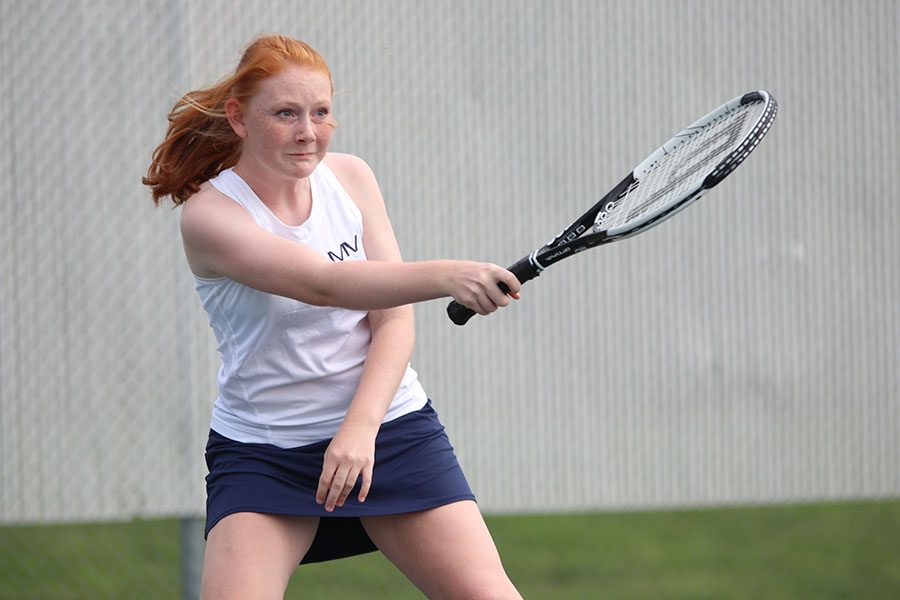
316, 422, 378, 512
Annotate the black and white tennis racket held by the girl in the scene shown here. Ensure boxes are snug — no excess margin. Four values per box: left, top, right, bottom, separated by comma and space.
447, 90, 778, 325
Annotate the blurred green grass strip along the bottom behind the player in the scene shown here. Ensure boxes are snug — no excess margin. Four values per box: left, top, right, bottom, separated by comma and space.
0, 502, 900, 600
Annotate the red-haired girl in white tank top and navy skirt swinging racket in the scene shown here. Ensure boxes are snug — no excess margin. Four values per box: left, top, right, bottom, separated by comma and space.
143, 35, 520, 600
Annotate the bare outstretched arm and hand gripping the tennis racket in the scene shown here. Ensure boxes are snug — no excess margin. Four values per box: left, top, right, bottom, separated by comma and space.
181, 185, 519, 314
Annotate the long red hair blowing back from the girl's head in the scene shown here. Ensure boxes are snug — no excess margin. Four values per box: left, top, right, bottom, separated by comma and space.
141, 35, 334, 206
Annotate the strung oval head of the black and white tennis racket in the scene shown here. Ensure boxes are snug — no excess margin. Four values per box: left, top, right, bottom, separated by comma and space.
592, 90, 778, 240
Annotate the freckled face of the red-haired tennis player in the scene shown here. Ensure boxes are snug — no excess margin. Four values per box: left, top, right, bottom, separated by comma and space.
236, 65, 334, 179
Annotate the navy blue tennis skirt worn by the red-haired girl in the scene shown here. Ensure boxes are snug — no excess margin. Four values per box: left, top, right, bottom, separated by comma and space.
206, 400, 475, 563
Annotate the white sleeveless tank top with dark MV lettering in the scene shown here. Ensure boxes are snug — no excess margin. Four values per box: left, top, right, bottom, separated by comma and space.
195, 163, 427, 448
